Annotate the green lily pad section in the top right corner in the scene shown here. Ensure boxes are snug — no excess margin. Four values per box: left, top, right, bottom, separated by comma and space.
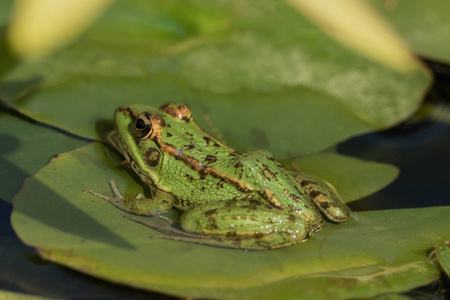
371, 0, 450, 63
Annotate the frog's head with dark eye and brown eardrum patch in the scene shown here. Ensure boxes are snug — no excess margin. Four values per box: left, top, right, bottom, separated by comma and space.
109, 102, 194, 186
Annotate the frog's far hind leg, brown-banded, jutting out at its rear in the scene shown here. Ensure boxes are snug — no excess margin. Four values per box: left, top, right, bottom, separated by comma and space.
291, 172, 350, 223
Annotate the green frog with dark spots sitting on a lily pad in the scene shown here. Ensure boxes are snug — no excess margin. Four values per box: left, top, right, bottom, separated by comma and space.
87, 102, 350, 250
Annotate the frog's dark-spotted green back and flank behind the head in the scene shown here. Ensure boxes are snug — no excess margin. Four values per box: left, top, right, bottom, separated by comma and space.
160, 133, 301, 209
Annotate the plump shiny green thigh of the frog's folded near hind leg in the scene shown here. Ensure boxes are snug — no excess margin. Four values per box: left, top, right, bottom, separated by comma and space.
180, 202, 310, 250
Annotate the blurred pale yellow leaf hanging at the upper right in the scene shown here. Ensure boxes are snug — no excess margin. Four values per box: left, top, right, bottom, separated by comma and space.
285, 0, 420, 72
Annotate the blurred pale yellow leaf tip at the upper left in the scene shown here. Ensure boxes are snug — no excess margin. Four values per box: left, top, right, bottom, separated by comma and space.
9, 0, 112, 59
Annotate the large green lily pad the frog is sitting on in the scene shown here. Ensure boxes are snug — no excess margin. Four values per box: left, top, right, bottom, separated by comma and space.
12, 143, 450, 299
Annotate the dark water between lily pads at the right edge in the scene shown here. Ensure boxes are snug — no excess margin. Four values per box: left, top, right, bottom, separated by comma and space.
338, 59, 450, 211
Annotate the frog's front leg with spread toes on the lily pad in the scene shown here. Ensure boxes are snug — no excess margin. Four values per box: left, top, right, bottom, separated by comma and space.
84, 180, 173, 219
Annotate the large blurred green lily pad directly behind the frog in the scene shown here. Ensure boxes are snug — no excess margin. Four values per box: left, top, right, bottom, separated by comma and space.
0, 0, 430, 158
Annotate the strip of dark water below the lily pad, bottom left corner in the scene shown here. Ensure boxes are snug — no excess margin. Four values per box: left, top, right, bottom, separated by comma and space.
0, 236, 164, 300
